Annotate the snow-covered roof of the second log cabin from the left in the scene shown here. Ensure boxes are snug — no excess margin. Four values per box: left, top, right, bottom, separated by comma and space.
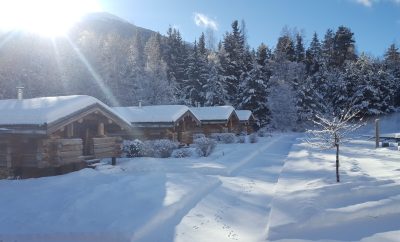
112, 105, 195, 123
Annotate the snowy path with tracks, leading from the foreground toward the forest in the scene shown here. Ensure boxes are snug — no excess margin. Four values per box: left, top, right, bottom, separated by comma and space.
174, 135, 296, 242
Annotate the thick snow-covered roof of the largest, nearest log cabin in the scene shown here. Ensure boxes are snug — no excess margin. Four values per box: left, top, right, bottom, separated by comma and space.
0, 95, 129, 125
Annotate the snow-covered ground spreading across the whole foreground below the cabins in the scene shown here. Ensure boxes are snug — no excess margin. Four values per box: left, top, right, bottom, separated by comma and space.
0, 115, 400, 242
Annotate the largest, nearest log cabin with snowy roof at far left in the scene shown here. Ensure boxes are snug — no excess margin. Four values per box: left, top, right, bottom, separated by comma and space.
0, 95, 130, 178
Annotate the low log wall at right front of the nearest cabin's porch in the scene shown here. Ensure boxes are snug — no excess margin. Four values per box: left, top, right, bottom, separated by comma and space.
93, 137, 122, 159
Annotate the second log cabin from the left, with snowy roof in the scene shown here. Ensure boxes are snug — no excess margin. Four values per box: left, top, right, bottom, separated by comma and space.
113, 105, 201, 144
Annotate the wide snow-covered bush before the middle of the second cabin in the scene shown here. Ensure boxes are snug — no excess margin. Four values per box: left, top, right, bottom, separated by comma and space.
145, 139, 178, 158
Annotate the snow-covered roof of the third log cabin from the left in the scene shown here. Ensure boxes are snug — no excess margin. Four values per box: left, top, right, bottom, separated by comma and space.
190, 106, 235, 121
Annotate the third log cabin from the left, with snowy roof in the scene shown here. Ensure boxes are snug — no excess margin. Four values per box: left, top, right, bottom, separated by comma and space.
190, 106, 239, 135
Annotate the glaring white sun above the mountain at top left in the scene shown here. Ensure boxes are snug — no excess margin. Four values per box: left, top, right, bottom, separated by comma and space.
0, 0, 101, 37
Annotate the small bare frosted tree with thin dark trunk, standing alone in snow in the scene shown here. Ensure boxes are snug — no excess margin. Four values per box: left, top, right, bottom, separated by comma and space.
306, 109, 363, 182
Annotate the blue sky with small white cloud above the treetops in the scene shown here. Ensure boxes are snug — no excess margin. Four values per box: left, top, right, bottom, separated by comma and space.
99, 0, 400, 56
